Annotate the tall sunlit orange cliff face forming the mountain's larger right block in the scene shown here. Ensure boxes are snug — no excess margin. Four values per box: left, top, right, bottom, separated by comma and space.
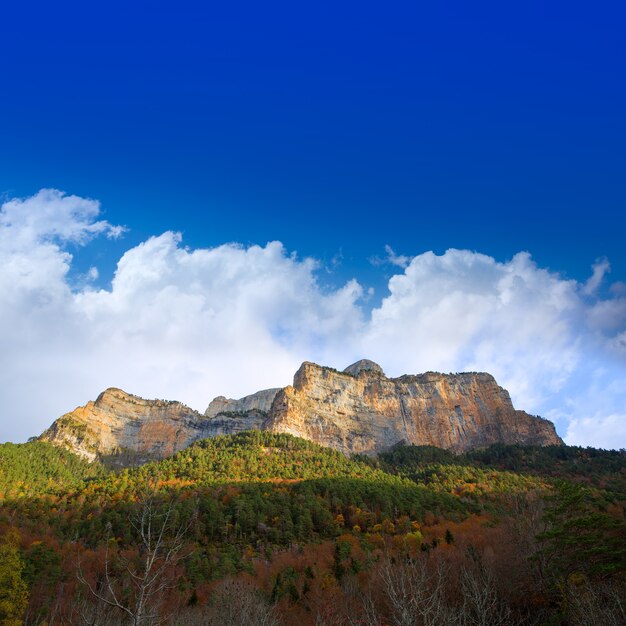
266, 362, 563, 454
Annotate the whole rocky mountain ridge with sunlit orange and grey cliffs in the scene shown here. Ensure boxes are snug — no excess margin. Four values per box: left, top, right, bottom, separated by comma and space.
41, 360, 562, 464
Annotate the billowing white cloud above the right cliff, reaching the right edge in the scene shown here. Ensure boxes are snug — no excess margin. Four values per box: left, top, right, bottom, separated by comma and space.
362, 250, 626, 447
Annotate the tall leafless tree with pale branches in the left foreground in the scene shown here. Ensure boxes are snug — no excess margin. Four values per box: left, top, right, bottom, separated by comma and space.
78, 483, 194, 626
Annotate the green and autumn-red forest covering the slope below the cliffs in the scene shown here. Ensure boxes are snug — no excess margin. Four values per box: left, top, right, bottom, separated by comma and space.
0, 432, 626, 626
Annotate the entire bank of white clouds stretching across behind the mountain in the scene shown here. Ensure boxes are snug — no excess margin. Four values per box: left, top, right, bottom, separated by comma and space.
0, 189, 626, 448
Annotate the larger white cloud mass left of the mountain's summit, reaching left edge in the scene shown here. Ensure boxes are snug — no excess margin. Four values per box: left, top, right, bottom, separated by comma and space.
0, 191, 363, 439
